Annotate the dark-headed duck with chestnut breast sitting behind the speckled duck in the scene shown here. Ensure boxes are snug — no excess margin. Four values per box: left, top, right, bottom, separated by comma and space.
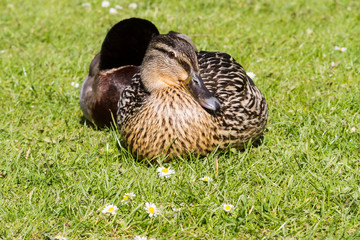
79, 18, 159, 129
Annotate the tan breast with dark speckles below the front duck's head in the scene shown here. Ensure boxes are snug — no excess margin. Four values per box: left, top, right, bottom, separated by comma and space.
122, 87, 220, 158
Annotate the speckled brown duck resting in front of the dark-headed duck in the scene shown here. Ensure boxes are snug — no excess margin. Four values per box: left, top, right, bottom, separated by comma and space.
82, 17, 268, 159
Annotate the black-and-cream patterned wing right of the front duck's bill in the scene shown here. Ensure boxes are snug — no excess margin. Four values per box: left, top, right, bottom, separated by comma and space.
198, 51, 268, 142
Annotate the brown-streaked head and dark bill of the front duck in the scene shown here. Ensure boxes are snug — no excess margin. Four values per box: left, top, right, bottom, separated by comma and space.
140, 32, 221, 111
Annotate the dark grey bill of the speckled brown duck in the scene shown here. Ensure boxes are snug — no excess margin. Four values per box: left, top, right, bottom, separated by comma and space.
184, 70, 221, 111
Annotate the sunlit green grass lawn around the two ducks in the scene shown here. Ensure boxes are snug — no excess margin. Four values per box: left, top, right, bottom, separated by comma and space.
0, 0, 360, 239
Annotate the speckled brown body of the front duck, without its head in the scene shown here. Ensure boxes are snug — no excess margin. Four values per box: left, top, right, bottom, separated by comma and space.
117, 48, 268, 159
